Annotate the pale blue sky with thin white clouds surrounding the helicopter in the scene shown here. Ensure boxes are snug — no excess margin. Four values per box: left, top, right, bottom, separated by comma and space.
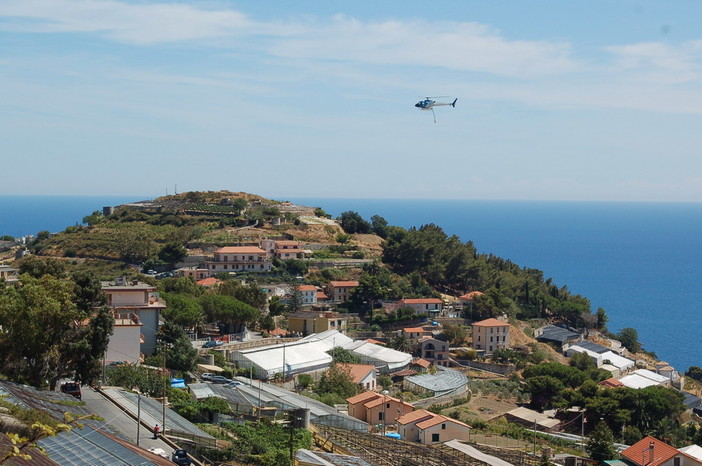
0, 0, 702, 202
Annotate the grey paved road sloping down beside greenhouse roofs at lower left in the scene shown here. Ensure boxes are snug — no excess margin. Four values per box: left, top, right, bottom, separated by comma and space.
82, 387, 173, 458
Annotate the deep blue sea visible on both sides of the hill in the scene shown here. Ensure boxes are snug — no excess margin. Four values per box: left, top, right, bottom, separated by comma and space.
0, 196, 702, 371
